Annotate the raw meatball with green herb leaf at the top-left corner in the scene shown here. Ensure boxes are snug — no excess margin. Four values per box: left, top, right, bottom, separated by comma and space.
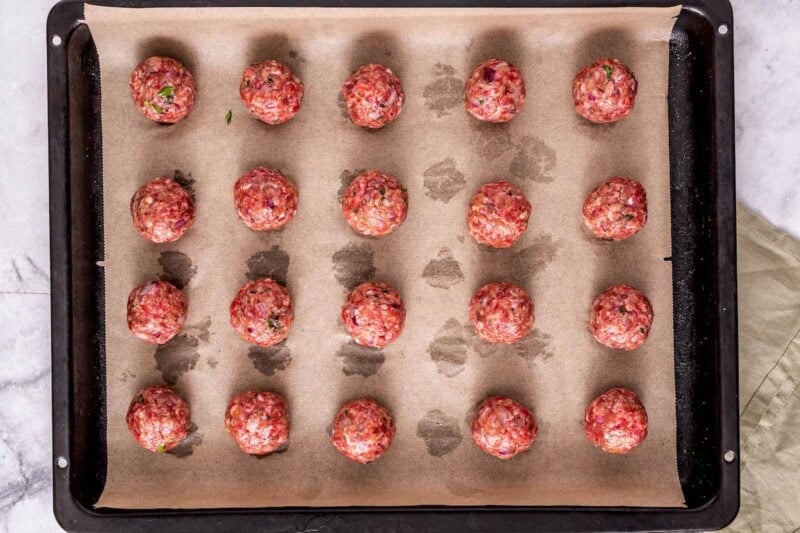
130, 56, 197, 124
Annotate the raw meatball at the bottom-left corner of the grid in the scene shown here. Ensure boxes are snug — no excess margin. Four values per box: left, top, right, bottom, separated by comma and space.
125, 387, 189, 453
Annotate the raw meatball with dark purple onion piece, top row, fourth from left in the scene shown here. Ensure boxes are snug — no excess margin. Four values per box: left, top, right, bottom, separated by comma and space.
465, 59, 525, 122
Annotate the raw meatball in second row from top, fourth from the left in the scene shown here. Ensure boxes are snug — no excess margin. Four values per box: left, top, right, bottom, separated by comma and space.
467, 181, 531, 248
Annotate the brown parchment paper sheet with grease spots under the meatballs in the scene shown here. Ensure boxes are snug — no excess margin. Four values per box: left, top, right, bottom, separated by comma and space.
86, 5, 683, 508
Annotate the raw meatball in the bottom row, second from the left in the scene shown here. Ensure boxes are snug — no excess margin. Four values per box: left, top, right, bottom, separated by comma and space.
225, 391, 289, 455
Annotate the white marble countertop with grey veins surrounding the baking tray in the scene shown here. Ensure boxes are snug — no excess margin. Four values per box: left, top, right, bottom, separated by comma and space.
0, 0, 800, 532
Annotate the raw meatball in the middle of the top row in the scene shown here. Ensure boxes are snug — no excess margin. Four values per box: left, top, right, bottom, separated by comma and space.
342, 65, 406, 129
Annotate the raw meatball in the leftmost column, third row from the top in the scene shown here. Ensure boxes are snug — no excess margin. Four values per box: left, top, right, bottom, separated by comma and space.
128, 281, 189, 344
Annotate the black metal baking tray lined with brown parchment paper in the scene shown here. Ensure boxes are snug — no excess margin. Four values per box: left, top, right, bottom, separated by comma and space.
47, 0, 739, 531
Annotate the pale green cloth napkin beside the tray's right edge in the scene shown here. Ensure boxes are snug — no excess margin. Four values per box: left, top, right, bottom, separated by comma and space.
727, 205, 800, 533
